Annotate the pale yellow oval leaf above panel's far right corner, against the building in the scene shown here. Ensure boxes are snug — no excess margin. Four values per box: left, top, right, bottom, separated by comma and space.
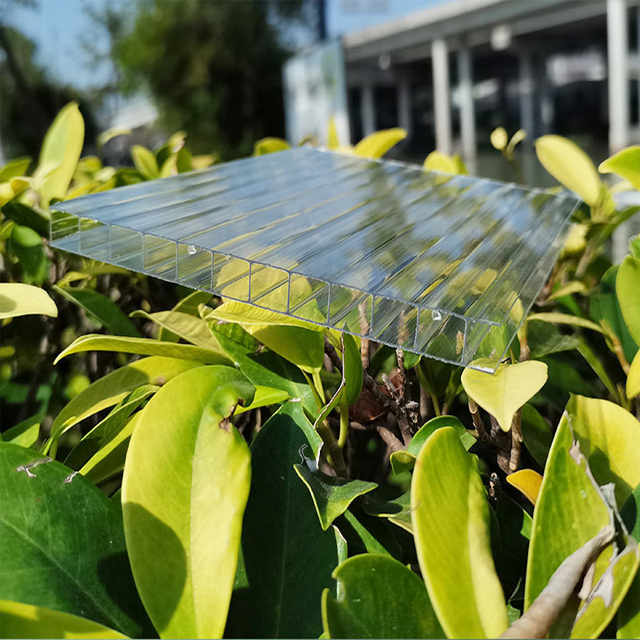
535, 135, 602, 207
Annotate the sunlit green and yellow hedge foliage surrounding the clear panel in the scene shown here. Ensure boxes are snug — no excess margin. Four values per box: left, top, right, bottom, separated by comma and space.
0, 104, 640, 638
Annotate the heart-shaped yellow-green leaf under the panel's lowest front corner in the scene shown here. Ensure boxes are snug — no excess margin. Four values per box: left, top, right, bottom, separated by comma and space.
462, 358, 547, 431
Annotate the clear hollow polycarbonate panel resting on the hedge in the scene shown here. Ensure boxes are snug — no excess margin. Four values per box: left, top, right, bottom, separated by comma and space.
51, 147, 579, 369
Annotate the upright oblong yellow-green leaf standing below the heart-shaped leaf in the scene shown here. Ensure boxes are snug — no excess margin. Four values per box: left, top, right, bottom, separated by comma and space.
411, 427, 508, 638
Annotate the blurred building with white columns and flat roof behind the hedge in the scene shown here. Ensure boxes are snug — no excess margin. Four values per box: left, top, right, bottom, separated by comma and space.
286, 0, 640, 258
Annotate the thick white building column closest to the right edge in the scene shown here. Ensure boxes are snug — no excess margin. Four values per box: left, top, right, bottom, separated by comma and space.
607, 0, 629, 153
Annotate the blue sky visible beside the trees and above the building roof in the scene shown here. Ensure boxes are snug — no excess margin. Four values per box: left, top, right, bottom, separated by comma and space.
9, 0, 447, 89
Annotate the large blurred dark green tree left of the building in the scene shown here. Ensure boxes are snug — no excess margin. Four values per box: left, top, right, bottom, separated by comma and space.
115, 0, 314, 158
